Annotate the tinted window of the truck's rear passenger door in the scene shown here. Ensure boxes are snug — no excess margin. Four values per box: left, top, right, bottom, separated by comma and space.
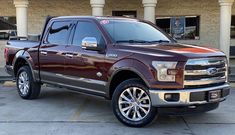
47, 21, 71, 45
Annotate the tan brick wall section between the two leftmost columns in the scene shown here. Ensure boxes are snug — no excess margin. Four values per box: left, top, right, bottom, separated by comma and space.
28, 0, 91, 34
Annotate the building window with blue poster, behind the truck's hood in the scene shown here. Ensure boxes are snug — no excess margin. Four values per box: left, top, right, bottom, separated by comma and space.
156, 16, 200, 40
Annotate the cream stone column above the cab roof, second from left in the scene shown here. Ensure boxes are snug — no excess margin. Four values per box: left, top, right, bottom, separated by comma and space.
90, 0, 105, 16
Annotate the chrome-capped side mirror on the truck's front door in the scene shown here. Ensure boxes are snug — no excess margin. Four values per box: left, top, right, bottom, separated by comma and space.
82, 37, 101, 51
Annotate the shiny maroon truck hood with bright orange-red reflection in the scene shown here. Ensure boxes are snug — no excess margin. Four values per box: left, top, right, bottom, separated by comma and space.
118, 43, 225, 61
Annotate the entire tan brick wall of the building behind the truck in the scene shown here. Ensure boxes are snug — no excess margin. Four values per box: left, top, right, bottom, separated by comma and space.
0, 0, 235, 48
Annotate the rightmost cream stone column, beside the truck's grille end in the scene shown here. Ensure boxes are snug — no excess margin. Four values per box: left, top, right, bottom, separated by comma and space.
219, 0, 234, 60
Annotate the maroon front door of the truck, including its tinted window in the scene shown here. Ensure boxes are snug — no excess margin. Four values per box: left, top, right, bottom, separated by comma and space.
65, 20, 106, 95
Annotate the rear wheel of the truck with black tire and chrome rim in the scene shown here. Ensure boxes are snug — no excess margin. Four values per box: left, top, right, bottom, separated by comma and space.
16, 66, 41, 99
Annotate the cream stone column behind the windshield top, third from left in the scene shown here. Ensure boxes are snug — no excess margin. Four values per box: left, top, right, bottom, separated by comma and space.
142, 0, 157, 24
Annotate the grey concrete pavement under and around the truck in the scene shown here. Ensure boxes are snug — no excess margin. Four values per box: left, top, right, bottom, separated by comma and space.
0, 86, 235, 135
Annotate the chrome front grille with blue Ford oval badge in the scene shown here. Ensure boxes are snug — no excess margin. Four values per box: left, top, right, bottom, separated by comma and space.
184, 58, 227, 87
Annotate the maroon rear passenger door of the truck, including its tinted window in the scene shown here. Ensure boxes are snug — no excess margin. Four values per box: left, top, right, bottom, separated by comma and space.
39, 20, 73, 84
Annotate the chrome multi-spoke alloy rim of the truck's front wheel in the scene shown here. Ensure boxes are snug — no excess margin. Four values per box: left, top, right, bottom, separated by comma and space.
118, 87, 151, 121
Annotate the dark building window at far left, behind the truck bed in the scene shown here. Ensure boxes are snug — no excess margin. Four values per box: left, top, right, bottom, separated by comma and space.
0, 16, 17, 40
